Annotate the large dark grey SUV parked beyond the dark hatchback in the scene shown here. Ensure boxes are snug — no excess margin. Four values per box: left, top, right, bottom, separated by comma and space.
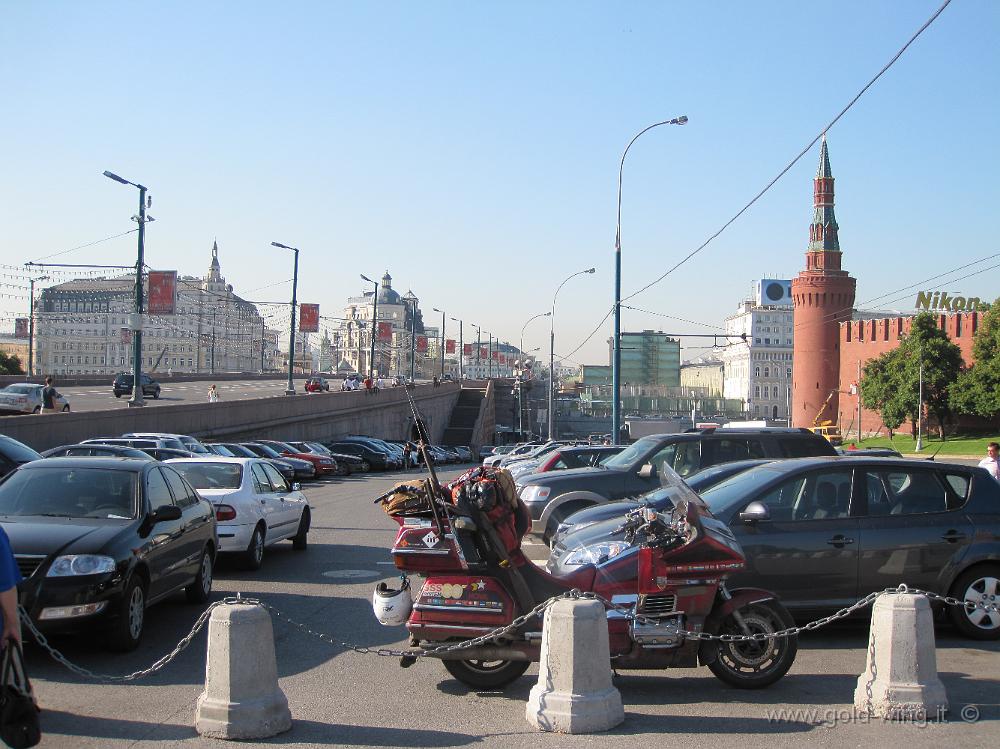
518, 428, 837, 541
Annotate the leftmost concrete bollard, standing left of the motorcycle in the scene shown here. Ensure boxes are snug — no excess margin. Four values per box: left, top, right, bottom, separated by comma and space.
194, 604, 292, 739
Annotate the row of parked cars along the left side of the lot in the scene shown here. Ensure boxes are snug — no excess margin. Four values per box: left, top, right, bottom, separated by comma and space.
0, 433, 471, 650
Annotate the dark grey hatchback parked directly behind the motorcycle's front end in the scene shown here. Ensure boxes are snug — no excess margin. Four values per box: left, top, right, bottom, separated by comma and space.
549, 457, 1000, 640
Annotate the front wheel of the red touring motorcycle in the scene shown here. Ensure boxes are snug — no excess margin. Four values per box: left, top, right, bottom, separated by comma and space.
708, 601, 798, 689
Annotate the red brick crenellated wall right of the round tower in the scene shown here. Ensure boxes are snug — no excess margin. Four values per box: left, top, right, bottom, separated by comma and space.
838, 312, 982, 438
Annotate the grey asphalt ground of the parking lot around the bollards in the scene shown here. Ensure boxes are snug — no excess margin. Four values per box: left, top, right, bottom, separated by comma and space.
27, 470, 1000, 749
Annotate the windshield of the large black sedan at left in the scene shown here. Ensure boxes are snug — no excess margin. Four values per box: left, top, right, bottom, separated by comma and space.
0, 466, 138, 520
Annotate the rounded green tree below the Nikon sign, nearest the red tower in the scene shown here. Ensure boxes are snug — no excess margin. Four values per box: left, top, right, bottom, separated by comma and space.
861, 312, 962, 439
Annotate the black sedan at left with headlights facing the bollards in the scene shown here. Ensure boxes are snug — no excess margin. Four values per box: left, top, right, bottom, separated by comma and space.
0, 457, 218, 650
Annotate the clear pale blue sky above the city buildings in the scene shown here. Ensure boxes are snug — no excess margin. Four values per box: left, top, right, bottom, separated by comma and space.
0, 0, 1000, 363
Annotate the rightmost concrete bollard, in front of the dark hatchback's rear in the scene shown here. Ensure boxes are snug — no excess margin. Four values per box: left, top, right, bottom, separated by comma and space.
854, 593, 948, 720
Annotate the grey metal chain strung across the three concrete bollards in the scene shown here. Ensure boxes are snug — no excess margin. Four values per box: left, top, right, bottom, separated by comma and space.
18, 584, 1000, 684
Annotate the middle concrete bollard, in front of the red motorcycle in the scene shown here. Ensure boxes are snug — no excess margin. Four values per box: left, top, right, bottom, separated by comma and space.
524, 600, 625, 733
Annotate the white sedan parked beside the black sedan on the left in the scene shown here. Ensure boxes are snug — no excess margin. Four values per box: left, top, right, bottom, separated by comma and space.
166, 456, 311, 570
